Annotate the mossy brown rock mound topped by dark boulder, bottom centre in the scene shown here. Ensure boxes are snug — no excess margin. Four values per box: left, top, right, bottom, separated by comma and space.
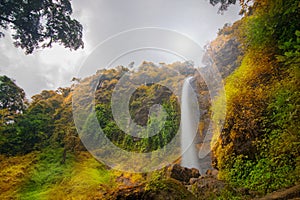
102, 164, 200, 200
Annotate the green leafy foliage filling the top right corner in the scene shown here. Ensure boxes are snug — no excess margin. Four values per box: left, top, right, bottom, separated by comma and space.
244, 0, 300, 54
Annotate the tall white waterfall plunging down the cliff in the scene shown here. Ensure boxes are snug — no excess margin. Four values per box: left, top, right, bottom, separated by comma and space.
181, 77, 200, 171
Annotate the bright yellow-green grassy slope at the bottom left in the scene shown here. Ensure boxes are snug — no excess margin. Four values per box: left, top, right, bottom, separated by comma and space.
17, 149, 116, 200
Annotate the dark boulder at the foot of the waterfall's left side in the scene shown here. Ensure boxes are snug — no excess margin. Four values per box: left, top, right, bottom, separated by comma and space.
168, 164, 200, 183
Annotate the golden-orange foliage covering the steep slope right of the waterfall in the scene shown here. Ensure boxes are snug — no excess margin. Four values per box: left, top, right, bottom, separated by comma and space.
212, 50, 273, 175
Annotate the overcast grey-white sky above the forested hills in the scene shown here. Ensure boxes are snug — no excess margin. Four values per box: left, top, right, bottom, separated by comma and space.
0, 0, 240, 98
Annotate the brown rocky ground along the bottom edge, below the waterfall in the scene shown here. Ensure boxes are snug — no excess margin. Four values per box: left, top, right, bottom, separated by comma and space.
102, 164, 300, 200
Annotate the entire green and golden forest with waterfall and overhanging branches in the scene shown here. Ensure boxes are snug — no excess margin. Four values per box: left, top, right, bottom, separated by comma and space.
0, 0, 300, 200
